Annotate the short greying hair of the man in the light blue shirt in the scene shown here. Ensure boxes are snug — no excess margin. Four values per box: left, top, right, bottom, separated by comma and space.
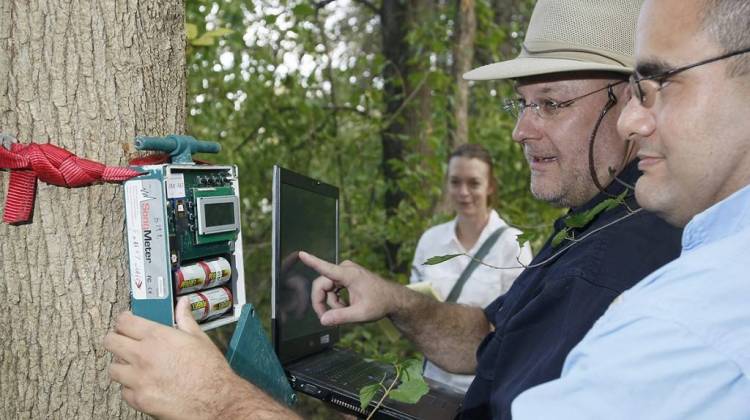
700, 0, 750, 77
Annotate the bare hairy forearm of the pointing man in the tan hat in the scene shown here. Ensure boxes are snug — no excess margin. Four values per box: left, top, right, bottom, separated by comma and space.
388, 288, 490, 373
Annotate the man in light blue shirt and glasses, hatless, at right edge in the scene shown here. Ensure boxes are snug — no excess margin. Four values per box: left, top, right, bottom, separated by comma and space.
513, 0, 750, 420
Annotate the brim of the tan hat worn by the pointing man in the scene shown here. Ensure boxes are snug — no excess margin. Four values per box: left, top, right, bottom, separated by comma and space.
463, 57, 633, 80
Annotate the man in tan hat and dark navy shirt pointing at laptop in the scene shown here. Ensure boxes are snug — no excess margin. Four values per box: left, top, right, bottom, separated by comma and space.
106, 0, 680, 419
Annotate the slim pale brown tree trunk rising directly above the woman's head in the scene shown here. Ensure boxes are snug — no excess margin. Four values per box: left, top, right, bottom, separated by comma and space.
448, 0, 477, 150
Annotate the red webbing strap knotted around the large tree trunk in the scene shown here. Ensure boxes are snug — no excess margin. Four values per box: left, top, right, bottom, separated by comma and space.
0, 142, 141, 223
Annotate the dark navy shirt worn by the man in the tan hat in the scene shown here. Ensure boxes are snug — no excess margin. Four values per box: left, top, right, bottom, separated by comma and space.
462, 163, 682, 419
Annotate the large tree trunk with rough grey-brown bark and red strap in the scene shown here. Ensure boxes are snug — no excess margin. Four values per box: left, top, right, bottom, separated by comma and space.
0, 0, 185, 419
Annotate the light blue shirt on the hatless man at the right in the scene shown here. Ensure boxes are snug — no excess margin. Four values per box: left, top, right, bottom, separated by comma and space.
512, 186, 750, 420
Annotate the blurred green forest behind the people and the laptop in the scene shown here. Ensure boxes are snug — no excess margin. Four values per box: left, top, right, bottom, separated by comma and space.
186, 0, 560, 411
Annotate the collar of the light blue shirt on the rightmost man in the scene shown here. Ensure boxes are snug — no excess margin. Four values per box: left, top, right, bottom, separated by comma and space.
682, 185, 750, 251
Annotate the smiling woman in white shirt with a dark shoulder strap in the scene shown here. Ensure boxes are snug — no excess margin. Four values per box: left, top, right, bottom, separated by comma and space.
411, 144, 532, 392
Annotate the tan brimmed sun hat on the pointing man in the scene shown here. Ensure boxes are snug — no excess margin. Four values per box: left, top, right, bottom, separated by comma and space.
464, 0, 643, 80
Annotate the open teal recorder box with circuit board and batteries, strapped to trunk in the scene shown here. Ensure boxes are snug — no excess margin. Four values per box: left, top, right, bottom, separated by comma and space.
125, 135, 245, 330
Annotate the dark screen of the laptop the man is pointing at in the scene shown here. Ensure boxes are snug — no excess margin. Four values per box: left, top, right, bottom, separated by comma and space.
272, 166, 339, 363
